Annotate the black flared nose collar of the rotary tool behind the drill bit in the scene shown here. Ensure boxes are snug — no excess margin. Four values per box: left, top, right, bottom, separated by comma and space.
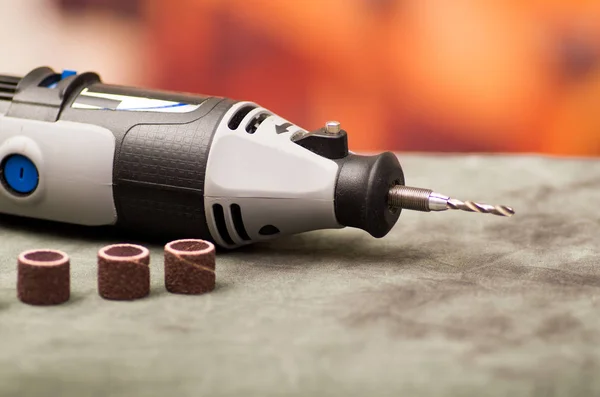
335, 152, 404, 238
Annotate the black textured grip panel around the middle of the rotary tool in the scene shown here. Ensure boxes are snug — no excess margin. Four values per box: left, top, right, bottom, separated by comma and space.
114, 101, 236, 240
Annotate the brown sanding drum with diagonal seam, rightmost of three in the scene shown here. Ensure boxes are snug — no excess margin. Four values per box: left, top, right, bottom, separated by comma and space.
165, 239, 216, 295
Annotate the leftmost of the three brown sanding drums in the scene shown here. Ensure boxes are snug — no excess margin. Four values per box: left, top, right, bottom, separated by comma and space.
17, 249, 71, 305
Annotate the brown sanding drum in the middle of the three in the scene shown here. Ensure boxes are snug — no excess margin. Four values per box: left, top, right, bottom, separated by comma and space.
98, 244, 150, 300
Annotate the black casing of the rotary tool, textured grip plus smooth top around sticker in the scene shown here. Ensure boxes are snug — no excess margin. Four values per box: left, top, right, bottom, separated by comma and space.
55, 78, 236, 241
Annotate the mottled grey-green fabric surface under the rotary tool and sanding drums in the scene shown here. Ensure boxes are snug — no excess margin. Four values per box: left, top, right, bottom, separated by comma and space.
0, 155, 600, 397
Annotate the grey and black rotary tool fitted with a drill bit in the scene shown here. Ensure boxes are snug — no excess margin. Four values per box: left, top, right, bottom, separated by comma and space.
0, 67, 514, 248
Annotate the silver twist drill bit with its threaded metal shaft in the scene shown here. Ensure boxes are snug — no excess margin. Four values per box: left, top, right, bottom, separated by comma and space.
388, 185, 515, 216
